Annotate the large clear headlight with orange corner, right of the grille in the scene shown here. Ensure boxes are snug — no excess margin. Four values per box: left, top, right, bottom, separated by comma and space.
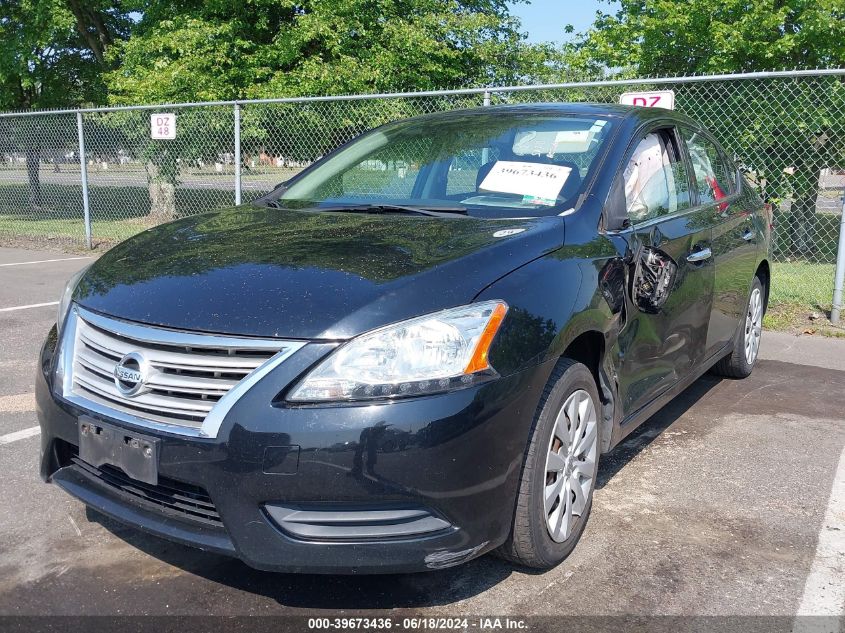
288, 301, 508, 402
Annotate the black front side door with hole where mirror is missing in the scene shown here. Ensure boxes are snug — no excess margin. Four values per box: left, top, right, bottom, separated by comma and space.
619, 126, 714, 416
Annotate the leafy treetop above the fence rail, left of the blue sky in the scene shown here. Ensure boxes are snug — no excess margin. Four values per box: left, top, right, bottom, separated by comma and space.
106, 0, 550, 103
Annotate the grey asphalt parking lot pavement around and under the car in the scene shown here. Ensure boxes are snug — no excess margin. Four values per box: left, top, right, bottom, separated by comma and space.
0, 248, 845, 630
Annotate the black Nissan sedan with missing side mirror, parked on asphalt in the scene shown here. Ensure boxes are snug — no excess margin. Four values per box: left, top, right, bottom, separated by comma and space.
36, 104, 770, 573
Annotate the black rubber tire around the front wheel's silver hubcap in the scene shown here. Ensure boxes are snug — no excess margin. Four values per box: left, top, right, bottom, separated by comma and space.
496, 359, 601, 569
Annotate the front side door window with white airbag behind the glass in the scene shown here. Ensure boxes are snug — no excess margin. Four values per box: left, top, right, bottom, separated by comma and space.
622, 129, 690, 224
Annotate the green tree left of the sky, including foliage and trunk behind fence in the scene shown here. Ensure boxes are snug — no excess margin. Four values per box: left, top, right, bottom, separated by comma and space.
100, 0, 553, 219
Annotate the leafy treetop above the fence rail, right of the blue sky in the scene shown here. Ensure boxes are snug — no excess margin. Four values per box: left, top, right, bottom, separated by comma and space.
579, 0, 845, 75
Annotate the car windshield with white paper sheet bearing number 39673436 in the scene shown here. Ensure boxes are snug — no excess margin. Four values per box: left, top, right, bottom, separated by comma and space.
271, 113, 612, 218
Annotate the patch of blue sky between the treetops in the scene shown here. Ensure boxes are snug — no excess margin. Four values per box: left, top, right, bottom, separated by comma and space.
504, 0, 616, 44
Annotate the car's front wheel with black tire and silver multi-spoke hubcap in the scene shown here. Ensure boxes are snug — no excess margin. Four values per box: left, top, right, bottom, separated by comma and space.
498, 359, 601, 569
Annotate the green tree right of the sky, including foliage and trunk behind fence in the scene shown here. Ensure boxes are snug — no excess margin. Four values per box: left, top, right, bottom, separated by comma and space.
570, 0, 845, 254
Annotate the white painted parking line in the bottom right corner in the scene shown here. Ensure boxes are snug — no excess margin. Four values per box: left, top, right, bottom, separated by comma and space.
793, 449, 845, 631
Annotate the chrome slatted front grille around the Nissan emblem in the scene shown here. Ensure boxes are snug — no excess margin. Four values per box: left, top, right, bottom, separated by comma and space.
63, 306, 303, 435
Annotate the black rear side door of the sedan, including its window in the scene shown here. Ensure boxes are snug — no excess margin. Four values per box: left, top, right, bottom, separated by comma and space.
681, 127, 758, 357
